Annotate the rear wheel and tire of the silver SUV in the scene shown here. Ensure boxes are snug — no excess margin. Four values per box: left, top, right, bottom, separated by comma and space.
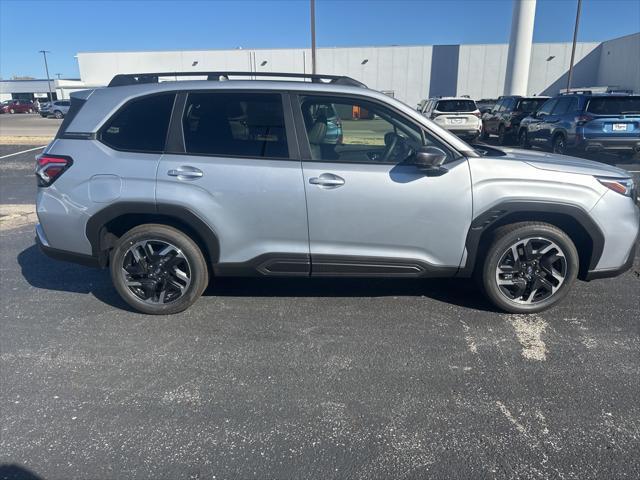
109, 224, 209, 315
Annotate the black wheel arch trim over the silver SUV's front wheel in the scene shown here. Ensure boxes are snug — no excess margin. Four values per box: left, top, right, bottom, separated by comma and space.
458, 202, 604, 280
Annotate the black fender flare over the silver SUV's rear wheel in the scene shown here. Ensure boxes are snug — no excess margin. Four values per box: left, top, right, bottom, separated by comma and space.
86, 202, 220, 266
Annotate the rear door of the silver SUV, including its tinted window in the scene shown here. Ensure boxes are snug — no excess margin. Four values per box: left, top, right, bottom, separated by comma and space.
157, 89, 309, 275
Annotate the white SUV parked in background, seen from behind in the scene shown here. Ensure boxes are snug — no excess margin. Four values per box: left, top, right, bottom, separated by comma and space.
420, 97, 482, 141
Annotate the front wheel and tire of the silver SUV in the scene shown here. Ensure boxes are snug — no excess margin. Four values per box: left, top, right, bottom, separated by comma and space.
479, 222, 579, 313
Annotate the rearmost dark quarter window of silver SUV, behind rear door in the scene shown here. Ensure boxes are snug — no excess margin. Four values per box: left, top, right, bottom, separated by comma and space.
100, 93, 175, 152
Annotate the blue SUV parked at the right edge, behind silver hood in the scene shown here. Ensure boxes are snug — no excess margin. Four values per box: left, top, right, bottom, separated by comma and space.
518, 92, 640, 157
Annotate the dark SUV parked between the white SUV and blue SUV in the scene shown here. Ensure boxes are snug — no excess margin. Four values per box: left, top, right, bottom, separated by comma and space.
482, 95, 549, 145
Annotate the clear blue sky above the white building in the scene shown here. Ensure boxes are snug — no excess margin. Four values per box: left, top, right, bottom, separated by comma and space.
0, 0, 640, 79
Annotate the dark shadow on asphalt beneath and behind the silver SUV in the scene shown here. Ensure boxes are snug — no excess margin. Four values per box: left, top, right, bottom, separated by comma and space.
18, 245, 494, 311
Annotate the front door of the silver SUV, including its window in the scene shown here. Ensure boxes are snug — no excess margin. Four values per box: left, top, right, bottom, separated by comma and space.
294, 95, 472, 276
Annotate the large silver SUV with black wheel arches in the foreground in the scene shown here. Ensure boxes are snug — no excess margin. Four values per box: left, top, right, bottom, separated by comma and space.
36, 72, 640, 314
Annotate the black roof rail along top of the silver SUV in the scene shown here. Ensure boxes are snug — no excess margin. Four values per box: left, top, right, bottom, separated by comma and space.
108, 72, 367, 88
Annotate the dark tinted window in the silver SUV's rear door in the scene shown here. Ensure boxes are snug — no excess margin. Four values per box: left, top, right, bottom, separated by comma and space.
182, 92, 289, 158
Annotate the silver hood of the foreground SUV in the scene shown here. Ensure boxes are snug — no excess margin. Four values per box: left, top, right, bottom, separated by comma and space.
502, 148, 631, 178
